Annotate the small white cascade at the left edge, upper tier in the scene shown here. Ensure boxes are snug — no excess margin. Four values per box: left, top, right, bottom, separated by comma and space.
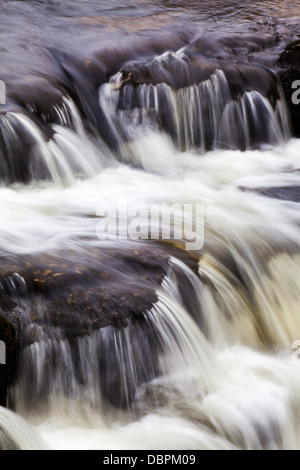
0, 98, 107, 184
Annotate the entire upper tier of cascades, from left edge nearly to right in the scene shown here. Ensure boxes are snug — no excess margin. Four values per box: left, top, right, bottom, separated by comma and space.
0, 64, 290, 184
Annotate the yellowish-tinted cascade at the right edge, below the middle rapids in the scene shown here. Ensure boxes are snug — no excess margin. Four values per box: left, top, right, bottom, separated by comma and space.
199, 252, 300, 348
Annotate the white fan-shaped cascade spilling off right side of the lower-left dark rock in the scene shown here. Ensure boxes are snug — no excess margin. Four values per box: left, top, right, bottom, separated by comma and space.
148, 290, 222, 399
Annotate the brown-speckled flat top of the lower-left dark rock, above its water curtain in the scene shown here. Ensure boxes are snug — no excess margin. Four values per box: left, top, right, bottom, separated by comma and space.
0, 245, 197, 341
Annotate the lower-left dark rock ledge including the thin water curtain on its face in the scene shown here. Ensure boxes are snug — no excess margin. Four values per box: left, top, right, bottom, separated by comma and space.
0, 243, 197, 408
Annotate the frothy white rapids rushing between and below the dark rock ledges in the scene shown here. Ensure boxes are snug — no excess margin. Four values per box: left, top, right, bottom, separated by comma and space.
0, 95, 300, 449
